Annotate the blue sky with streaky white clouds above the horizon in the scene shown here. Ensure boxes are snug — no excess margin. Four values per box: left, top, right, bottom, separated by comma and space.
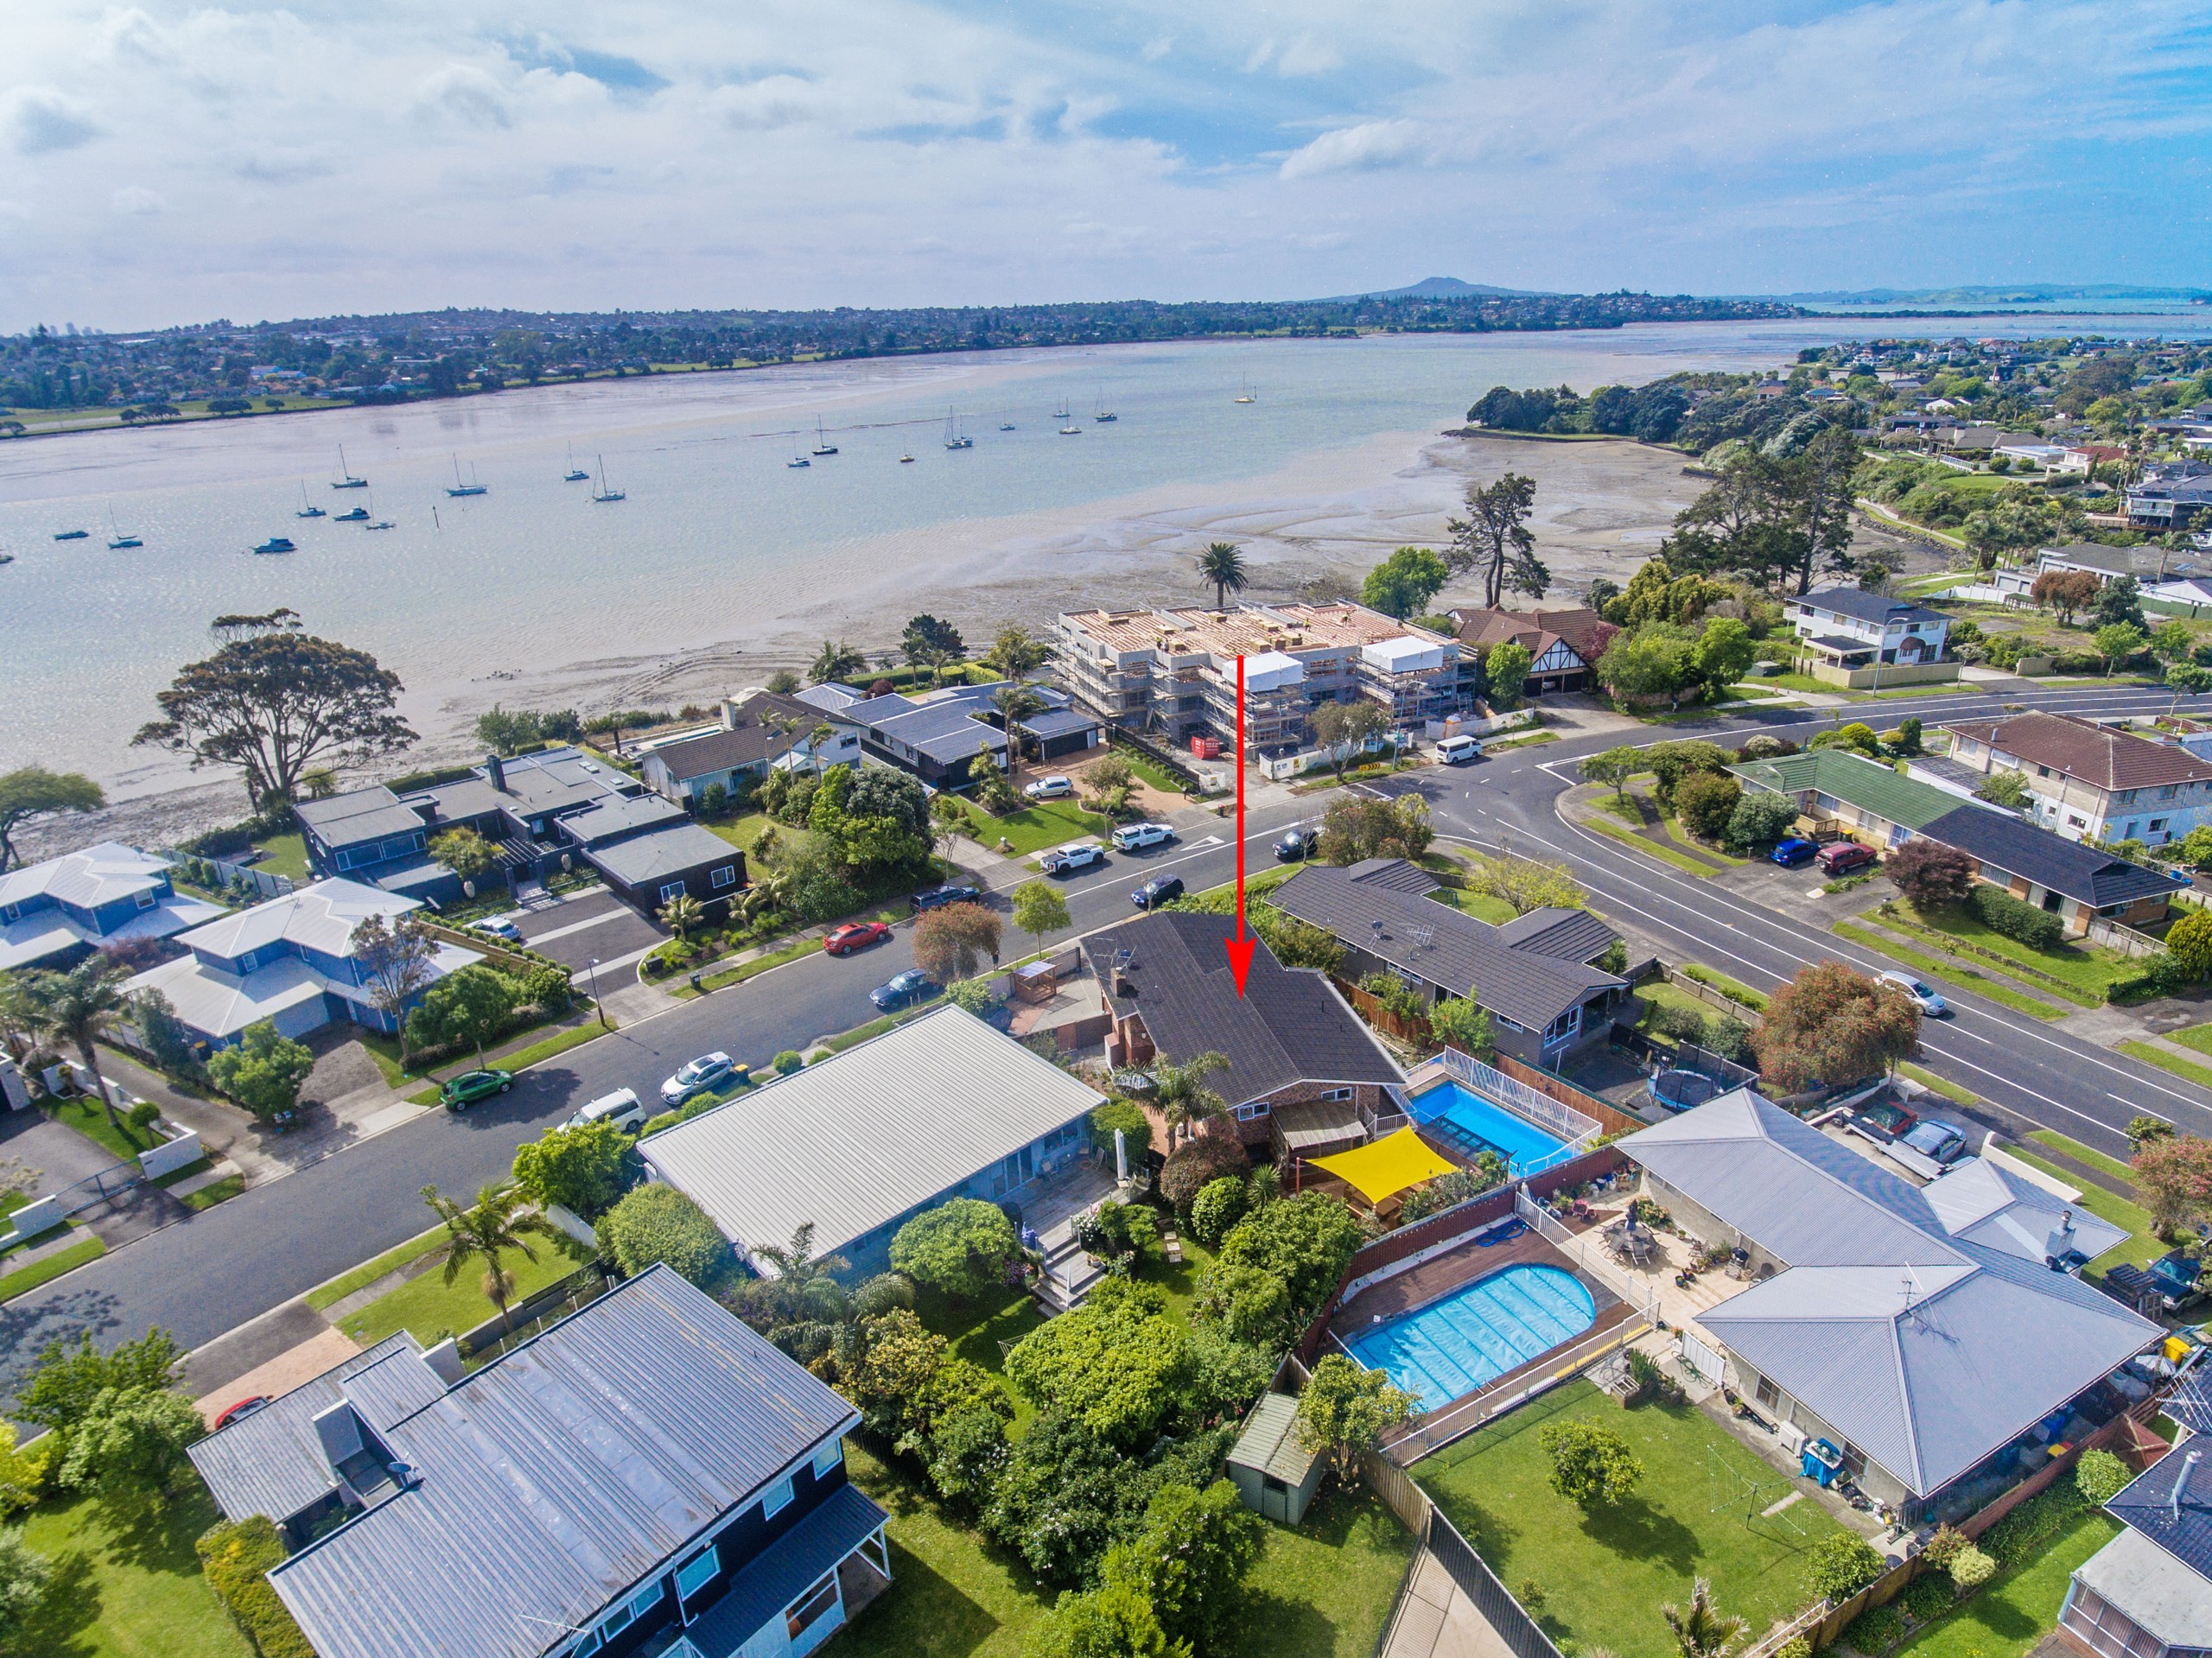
0, 0, 2212, 329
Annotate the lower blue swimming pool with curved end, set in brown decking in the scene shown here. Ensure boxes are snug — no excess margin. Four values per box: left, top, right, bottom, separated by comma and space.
1344, 1262, 1597, 1410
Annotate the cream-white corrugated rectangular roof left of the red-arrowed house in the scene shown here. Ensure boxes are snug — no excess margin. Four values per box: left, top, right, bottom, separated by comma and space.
637, 1006, 1106, 1254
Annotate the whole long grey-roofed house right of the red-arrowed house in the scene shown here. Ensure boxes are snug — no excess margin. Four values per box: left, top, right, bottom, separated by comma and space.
1268, 858, 1635, 1070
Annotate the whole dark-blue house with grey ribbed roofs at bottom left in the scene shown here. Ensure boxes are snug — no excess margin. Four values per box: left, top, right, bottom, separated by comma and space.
190, 1265, 892, 1658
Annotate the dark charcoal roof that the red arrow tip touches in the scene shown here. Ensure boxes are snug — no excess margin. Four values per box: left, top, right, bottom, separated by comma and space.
1084, 911, 1405, 1105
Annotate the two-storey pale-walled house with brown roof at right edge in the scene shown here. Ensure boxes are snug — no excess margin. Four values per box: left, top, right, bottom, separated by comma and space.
1944, 714, 2212, 847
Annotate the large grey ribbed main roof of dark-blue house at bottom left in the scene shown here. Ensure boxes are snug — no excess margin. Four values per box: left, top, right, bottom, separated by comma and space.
270, 1267, 856, 1658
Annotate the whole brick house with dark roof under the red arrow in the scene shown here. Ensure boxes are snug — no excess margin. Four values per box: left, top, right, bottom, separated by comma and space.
1082, 911, 1405, 1160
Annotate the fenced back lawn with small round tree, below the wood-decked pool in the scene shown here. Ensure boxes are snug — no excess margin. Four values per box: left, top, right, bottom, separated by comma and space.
1414, 1380, 1838, 1658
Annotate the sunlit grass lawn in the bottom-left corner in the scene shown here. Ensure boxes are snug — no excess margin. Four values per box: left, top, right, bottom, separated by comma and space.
20, 1479, 252, 1658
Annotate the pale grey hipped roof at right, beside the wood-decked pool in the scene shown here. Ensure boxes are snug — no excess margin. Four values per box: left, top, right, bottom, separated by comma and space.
1619, 1088, 2161, 1496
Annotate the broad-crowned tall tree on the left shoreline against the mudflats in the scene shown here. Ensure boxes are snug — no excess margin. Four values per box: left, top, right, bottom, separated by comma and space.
130, 617, 416, 811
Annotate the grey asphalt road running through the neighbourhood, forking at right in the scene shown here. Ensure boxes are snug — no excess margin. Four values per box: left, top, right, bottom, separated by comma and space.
0, 676, 2212, 1386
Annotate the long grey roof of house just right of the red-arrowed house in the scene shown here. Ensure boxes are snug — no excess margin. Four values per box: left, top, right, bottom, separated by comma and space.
1268, 858, 1621, 1030
